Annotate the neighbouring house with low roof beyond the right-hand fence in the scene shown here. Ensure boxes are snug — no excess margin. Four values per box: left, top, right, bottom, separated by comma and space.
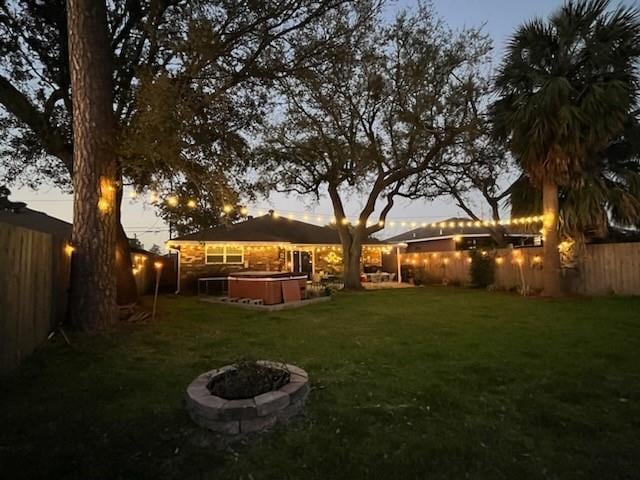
386, 218, 542, 253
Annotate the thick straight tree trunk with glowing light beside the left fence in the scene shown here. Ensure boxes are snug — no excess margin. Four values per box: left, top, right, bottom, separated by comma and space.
67, 0, 117, 331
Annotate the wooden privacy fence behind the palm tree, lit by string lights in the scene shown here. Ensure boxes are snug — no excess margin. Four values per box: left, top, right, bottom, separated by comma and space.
401, 243, 640, 295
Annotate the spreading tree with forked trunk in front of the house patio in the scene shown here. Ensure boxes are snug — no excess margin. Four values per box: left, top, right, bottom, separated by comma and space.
259, 5, 489, 289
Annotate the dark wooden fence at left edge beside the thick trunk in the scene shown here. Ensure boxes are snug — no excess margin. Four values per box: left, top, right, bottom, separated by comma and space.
0, 223, 69, 373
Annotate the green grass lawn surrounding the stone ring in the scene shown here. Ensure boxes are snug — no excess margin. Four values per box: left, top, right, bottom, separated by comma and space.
0, 288, 640, 480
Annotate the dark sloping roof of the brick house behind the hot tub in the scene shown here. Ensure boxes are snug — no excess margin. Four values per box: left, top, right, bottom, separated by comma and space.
171, 213, 384, 245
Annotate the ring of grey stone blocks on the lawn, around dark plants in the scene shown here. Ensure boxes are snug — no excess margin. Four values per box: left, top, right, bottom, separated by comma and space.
186, 361, 309, 435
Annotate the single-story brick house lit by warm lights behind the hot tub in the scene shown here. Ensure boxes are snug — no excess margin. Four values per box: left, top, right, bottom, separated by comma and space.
167, 211, 389, 291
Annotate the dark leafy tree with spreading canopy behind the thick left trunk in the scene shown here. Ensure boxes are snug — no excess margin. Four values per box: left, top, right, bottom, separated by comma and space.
0, 0, 345, 304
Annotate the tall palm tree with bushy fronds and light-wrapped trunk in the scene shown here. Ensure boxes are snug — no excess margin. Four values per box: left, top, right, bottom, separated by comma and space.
491, 0, 640, 296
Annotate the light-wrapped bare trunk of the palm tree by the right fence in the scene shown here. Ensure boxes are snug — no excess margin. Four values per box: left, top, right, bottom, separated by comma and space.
542, 180, 562, 297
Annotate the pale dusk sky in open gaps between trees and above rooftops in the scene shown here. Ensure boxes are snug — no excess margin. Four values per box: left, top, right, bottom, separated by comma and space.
12, 0, 576, 248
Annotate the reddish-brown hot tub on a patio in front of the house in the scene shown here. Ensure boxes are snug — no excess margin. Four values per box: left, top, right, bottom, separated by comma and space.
229, 271, 307, 305
